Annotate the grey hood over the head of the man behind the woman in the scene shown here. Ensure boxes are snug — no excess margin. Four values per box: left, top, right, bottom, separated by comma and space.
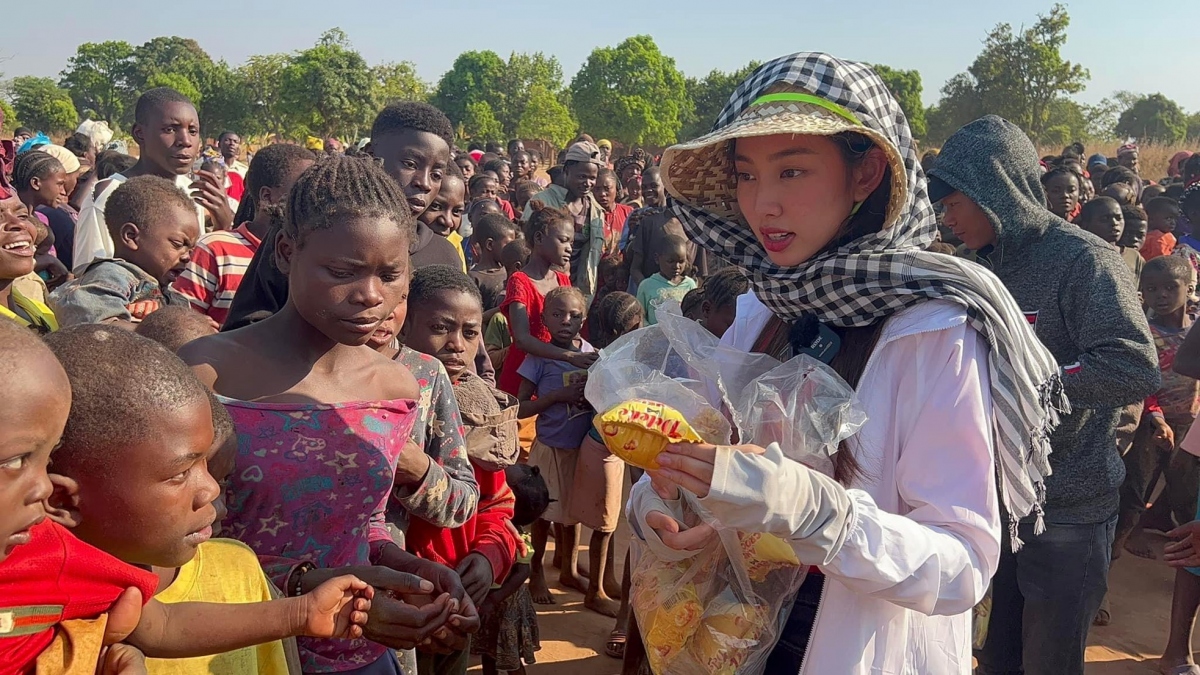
930, 115, 1067, 250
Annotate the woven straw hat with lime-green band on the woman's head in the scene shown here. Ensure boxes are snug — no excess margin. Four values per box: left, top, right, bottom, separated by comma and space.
662, 85, 908, 227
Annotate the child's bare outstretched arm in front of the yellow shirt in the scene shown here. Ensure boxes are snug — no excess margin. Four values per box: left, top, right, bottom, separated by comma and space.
125, 575, 374, 658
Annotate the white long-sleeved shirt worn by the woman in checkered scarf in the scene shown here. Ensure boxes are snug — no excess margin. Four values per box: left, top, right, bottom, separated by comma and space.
629, 294, 1001, 675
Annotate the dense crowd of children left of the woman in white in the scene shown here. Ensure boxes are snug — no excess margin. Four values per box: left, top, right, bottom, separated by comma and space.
0, 84, 748, 675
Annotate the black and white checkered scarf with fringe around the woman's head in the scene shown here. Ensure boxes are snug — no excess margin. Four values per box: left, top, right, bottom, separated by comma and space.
670, 53, 1069, 546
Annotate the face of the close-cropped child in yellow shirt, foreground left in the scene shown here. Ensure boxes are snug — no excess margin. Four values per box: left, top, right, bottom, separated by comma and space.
71, 398, 221, 567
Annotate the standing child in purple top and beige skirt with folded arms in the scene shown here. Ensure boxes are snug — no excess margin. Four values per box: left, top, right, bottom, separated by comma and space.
517, 283, 600, 604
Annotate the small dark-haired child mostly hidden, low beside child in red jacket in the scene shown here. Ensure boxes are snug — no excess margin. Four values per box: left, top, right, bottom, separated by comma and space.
470, 464, 550, 675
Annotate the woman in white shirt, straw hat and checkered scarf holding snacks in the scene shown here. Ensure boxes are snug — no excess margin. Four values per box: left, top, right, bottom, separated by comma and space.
629, 53, 1067, 675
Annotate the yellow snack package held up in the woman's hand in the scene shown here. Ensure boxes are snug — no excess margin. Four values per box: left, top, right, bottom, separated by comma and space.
593, 399, 703, 470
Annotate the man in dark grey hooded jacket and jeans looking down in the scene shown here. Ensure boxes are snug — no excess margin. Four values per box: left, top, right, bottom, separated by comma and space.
929, 115, 1159, 675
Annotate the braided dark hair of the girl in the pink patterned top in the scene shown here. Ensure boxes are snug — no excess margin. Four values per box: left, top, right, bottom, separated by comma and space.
283, 155, 416, 247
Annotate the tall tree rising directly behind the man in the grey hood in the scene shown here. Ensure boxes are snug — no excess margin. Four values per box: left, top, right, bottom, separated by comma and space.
926, 5, 1091, 139
